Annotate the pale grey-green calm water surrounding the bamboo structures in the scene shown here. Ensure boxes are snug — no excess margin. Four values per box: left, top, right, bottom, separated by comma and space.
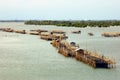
0, 22, 120, 80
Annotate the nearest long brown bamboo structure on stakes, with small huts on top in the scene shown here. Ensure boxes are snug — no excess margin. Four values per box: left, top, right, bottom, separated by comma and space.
52, 39, 116, 68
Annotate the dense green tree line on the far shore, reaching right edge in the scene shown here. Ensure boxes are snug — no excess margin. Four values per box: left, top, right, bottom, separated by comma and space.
25, 20, 120, 27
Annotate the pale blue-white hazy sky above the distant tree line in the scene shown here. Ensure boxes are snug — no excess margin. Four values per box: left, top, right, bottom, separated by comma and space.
0, 0, 120, 20
